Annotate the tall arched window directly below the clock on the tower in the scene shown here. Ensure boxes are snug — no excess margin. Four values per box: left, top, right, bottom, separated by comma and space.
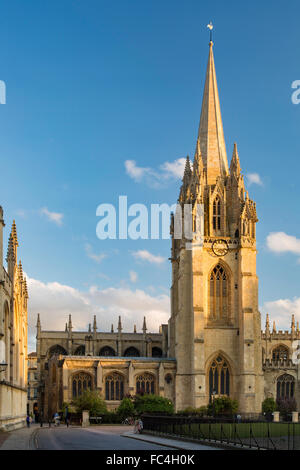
209, 264, 229, 320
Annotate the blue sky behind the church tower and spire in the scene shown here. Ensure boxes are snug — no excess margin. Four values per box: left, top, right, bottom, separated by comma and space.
0, 0, 300, 346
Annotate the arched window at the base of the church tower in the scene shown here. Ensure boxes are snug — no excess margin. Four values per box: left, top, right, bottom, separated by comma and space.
209, 356, 230, 399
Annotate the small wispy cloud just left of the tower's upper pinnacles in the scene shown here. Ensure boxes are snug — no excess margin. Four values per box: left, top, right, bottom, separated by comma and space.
125, 158, 185, 188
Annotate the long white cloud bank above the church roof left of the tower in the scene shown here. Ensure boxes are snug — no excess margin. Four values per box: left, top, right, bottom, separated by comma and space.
28, 278, 170, 351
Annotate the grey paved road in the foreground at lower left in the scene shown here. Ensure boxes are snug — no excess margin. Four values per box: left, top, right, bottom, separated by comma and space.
35, 426, 173, 450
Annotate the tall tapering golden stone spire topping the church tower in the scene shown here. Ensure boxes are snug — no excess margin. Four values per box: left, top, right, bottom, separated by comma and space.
198, 41, 228, 184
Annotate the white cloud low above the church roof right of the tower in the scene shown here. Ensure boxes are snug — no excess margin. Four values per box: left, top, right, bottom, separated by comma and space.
262, 297, 300, 330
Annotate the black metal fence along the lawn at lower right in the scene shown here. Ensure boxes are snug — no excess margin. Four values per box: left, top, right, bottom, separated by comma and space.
142, 415, 300, 450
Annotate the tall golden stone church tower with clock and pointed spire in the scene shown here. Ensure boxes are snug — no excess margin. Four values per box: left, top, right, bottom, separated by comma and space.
169, 37, 263, 413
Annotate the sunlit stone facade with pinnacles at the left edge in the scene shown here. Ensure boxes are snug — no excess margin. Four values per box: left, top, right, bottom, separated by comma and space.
0, 215, 28, 429
